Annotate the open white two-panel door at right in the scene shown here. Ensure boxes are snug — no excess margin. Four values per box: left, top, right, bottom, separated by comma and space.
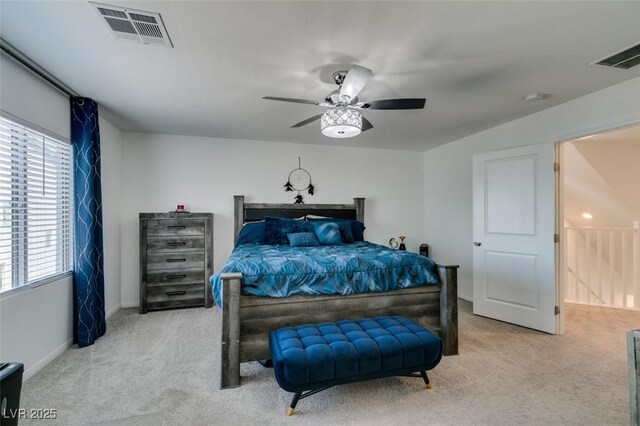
469, 144, 556, 333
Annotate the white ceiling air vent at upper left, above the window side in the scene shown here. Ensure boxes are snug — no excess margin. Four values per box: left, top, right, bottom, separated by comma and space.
89, 2, 173, 47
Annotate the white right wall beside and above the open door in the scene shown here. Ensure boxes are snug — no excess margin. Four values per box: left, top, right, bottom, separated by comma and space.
424, 78, 640, 299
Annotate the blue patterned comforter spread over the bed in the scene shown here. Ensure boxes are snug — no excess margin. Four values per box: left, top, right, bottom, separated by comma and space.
209, 241, 438, 306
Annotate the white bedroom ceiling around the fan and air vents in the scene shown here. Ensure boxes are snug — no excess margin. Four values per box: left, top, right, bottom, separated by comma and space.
0, 0, 640, 151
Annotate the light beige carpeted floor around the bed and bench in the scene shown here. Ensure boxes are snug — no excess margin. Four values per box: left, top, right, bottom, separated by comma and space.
20, 301, 640, 426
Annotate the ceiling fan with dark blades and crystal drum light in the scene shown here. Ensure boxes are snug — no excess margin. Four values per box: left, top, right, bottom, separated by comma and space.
262, 65, 426, 138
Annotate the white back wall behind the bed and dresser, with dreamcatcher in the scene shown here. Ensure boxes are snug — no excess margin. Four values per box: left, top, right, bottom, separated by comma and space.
120, 133, 424, 306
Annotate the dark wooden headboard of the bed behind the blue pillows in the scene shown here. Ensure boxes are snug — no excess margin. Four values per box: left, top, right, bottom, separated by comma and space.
233, 195, 364, 242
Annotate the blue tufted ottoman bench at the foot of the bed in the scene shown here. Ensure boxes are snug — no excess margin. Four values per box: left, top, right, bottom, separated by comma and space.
269, 316, 442, 416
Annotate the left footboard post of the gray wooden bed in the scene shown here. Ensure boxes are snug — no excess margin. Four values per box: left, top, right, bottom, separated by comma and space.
220, 273, 242, 389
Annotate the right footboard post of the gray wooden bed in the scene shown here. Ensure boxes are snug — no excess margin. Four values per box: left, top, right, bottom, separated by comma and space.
438, 265, 458, 355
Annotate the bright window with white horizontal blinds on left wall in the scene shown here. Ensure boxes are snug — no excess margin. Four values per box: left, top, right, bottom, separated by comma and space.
0, 117, 73, 292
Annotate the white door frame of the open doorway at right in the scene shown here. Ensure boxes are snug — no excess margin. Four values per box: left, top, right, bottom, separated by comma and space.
554, 117, 640, 334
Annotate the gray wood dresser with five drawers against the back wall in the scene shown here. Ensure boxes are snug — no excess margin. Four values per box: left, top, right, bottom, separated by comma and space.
140, 213, 213, 314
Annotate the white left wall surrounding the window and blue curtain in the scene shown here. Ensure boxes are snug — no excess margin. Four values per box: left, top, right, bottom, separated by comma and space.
0, 56, 122, 378
